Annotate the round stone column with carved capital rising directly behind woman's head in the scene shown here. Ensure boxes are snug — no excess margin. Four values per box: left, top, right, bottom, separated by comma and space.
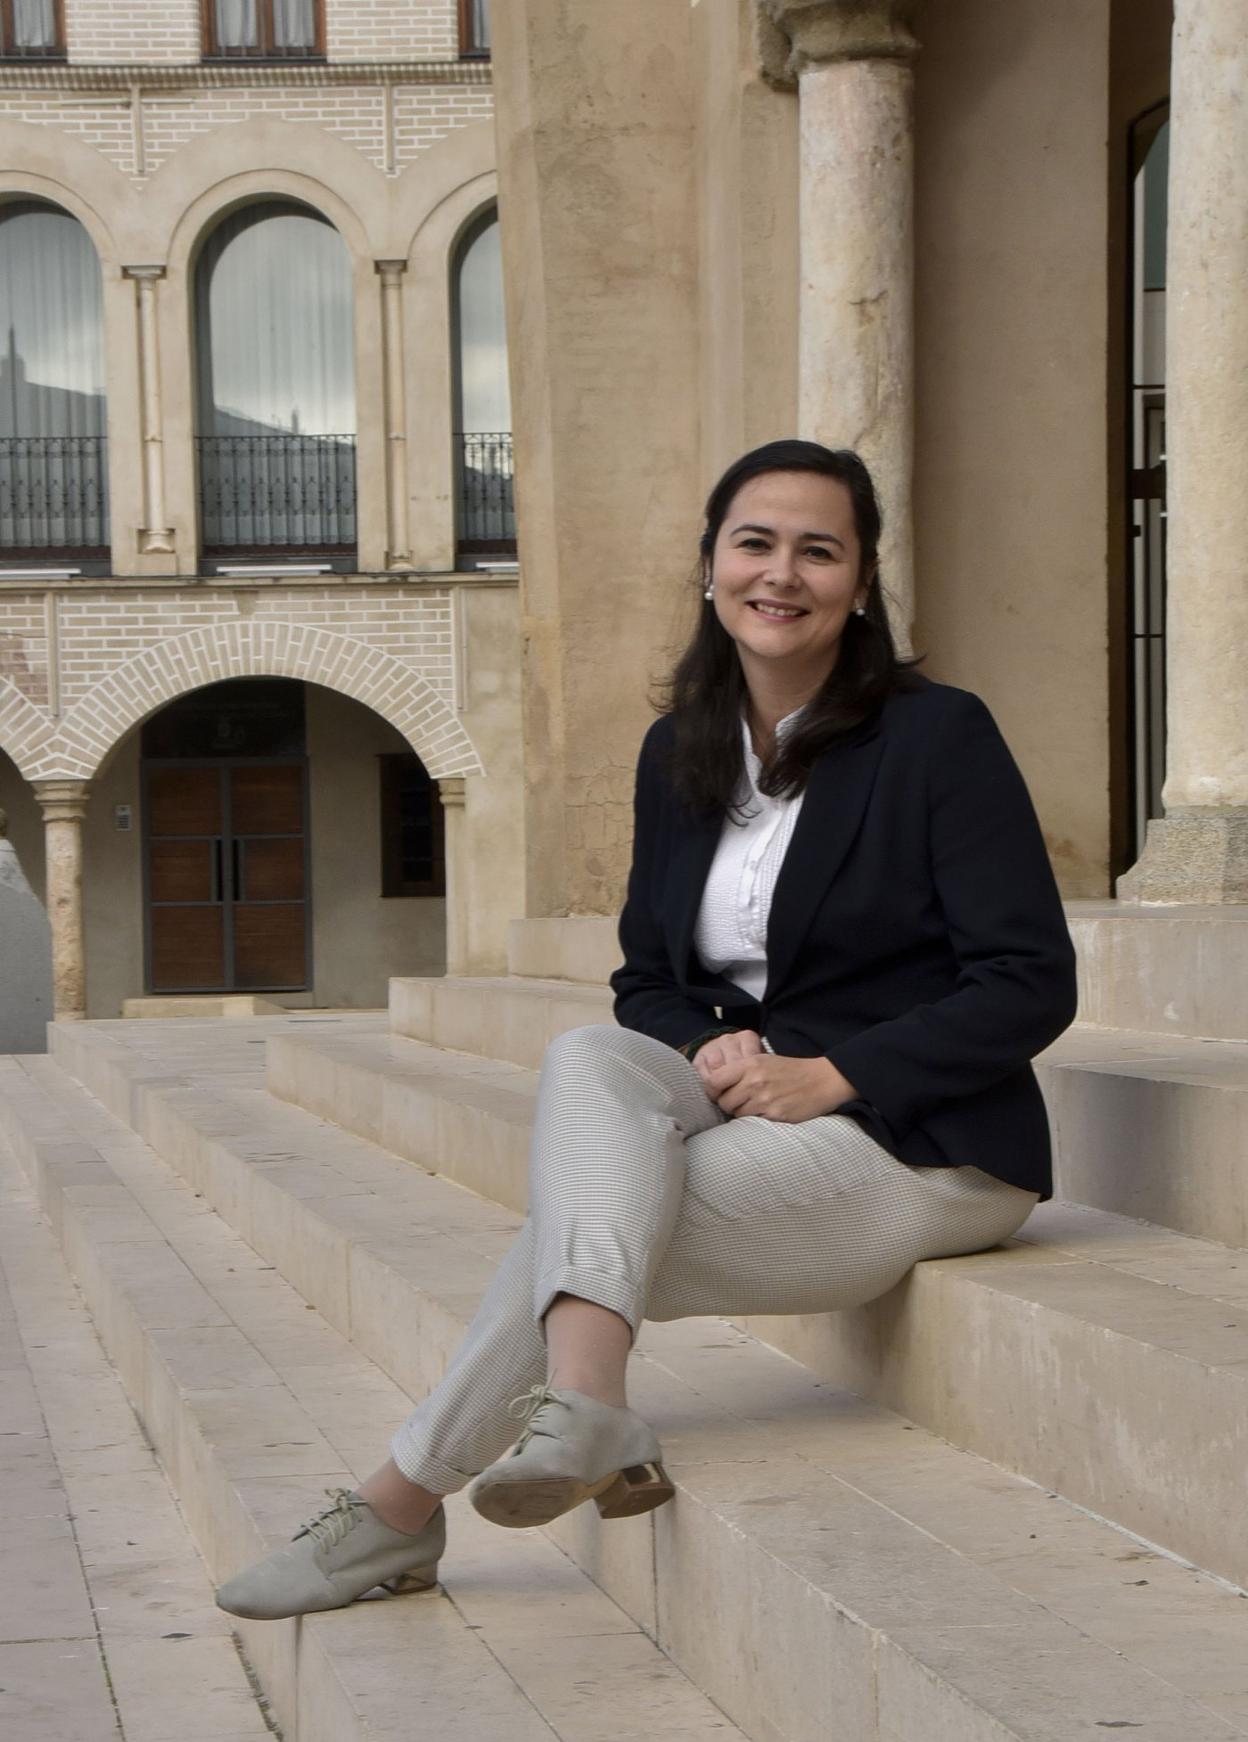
762, 0, 919, 648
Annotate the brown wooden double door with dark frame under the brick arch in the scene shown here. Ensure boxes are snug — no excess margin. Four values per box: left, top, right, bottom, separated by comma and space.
143, 758, 310, 993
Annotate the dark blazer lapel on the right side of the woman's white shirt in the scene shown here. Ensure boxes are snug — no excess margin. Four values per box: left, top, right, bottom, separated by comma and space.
763, 716, 884, 998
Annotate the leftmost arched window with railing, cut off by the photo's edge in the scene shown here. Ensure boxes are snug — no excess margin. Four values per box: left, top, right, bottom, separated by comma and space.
0, 200, 108, 568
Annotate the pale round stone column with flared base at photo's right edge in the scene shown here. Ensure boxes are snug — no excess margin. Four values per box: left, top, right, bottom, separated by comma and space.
1117, 0, 1248, 904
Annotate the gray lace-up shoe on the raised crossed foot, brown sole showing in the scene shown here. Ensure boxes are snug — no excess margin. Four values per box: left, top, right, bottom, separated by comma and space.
469, 1385, 675, 1528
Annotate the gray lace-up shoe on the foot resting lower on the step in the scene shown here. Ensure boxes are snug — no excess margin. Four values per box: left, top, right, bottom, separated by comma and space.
216, 1488, 446, 1622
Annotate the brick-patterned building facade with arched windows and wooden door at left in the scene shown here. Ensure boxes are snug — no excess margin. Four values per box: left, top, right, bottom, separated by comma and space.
0, 0, 521, 1016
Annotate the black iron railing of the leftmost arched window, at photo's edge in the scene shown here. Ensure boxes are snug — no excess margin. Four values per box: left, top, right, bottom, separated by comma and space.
0, 436, 108, 556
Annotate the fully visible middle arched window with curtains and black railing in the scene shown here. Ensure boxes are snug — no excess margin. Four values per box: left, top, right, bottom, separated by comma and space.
195, 200, 356, 568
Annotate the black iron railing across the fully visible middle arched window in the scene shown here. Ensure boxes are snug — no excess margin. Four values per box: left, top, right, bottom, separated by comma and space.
195, 432, 356, 556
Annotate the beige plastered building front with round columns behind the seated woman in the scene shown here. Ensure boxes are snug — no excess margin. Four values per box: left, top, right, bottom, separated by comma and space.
495, 0, 1248, 915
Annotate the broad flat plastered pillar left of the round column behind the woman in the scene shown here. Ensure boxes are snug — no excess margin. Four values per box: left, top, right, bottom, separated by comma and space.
492, 0, 704, 918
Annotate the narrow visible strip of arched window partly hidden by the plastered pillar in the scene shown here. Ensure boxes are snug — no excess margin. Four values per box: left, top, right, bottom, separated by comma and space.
451, 211, 516, 554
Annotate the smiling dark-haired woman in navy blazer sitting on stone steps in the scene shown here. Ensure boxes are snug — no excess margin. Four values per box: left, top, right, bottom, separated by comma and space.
218, 441, 1075, 1618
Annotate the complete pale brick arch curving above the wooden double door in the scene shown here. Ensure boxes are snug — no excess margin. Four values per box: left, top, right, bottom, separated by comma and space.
25, 618, 483, 780
